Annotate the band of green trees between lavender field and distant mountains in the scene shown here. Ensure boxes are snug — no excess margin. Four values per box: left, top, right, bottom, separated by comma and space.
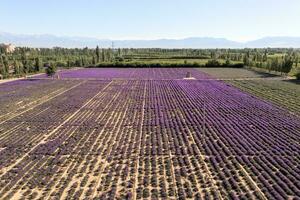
0, 46, 300, 78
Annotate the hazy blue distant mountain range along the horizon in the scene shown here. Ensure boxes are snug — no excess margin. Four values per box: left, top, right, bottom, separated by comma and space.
0, 32, 300, 48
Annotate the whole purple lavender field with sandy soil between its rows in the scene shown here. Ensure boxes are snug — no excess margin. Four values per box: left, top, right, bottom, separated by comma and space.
0, 68, 300, 200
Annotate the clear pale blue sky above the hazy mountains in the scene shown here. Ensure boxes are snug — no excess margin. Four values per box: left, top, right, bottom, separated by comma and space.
0, 0, 300, 41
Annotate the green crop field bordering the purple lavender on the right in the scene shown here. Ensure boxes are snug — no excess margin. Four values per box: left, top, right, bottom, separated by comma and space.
199, 68, 300, 114
